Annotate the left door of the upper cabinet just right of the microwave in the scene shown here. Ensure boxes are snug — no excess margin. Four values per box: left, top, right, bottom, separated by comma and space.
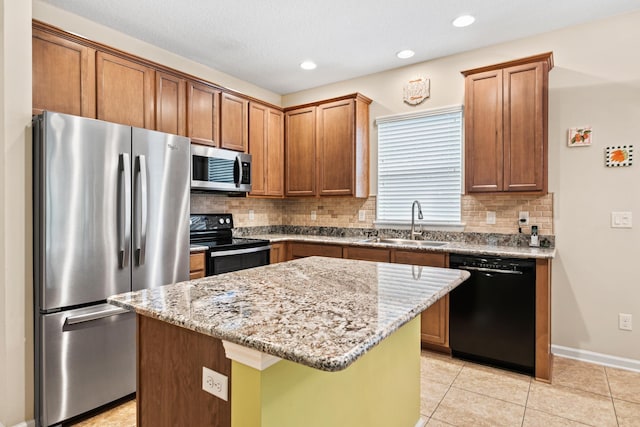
249, 102, 266, 196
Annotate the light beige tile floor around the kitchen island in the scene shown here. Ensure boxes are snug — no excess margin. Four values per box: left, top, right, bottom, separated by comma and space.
74, 351, 640, 427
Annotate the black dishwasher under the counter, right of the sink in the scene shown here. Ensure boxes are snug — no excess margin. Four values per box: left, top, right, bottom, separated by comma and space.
449, 254, 536, 374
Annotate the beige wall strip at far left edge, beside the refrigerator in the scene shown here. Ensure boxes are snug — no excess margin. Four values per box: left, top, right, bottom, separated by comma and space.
0, 0, 33, 426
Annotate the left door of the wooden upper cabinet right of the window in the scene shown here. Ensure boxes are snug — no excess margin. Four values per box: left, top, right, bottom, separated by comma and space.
465, 70, 503, 192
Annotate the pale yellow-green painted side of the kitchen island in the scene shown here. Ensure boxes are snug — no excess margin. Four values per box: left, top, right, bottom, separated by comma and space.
232, 318, 420, 427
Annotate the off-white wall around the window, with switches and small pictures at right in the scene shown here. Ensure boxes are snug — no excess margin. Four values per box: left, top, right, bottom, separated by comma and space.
283, 13, 640, 362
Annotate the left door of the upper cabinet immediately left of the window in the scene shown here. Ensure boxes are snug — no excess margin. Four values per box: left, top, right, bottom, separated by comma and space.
285, 107, 316, 196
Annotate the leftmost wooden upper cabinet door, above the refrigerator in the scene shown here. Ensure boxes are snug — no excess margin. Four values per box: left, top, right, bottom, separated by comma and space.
32, 29, 96, 118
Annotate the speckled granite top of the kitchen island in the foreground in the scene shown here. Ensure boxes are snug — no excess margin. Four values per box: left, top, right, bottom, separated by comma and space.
108, 257, 469, 371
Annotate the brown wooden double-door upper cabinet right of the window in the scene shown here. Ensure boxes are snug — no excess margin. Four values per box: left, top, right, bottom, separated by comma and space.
462, 52, 553, 193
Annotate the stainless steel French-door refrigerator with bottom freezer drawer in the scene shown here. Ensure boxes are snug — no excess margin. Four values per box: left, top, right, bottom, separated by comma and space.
33, 112, 190, 426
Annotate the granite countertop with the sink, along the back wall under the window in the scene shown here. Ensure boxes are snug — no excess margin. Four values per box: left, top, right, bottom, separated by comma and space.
250, 234, 556, 259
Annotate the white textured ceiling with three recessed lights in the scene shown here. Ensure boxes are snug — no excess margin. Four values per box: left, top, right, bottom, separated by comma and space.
44, 0, 640, 95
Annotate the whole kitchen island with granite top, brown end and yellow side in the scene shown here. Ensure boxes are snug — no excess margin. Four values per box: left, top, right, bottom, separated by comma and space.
109, 257, 468, 427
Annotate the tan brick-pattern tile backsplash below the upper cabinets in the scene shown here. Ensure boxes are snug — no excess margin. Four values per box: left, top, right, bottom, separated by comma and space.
191, 193, 553, 235
